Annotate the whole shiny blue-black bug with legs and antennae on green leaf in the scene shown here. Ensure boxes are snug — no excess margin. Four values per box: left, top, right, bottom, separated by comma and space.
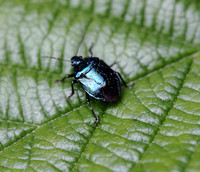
41, 45, 133, 126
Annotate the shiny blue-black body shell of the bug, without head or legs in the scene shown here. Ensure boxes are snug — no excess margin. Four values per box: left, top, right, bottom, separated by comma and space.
74, 57, 121, 102
